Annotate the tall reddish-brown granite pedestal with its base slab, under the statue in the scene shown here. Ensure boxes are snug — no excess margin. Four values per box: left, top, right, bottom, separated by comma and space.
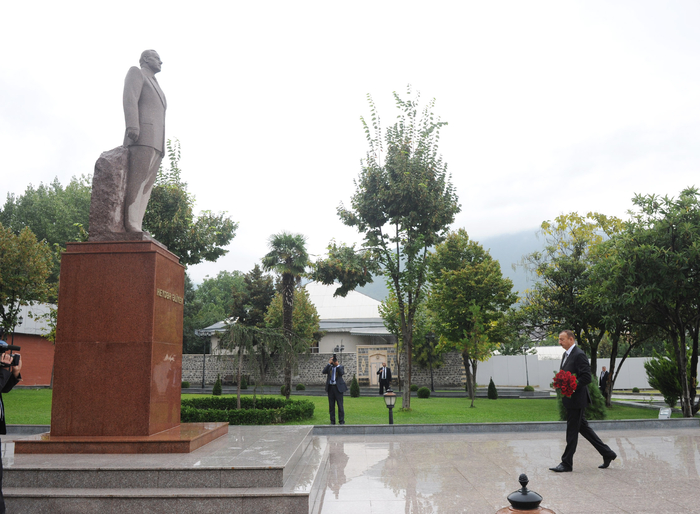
15, 241, 225, 453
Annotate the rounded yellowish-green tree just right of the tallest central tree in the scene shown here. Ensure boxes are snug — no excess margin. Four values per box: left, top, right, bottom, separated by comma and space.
428, 229, 518, 407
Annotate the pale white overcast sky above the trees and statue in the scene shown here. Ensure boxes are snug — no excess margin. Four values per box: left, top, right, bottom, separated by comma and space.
0, 0, 700, 282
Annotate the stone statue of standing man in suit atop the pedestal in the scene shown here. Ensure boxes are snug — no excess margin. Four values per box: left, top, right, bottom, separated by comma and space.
124, 50, 167, 232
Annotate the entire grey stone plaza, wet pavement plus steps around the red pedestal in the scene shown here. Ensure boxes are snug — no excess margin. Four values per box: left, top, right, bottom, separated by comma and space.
3, 419, 700, 514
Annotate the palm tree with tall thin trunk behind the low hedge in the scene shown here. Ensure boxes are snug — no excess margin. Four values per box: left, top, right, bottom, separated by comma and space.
262, 232, 309, 398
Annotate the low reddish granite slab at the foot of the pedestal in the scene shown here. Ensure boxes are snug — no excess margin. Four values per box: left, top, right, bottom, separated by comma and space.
15, 423, 228, 454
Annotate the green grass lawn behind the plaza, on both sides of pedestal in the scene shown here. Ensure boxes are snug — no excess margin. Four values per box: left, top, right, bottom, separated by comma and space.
3, 389, 680, 425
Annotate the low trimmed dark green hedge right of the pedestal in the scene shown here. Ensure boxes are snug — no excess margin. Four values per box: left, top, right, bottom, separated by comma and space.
180, 397, 314, 425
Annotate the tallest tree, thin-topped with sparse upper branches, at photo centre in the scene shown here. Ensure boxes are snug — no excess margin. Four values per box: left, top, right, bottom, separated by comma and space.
313, 87, 460, 409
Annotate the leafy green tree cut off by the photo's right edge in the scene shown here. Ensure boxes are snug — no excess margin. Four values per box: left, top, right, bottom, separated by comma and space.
592, 188, 700, 417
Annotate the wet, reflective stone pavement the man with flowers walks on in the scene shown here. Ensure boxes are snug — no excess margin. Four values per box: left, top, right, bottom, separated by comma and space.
321, 429, 700, 514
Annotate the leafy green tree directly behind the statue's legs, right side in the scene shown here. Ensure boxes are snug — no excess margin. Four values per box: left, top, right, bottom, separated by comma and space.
143, 139, 238, 266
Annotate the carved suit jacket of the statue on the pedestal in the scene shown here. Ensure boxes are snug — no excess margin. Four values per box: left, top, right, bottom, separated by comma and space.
124, 66, 167, 153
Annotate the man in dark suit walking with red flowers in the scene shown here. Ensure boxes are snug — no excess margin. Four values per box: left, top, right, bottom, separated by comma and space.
549, 330, 617, 473
